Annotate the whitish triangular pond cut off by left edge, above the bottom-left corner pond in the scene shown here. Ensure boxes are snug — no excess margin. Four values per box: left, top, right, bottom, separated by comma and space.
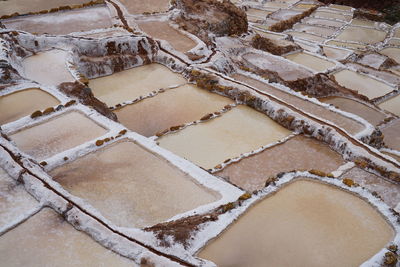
0, 168, 40, 228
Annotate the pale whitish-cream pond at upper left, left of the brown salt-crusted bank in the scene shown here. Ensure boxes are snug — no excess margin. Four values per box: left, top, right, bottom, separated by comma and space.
22, 50, 74, 85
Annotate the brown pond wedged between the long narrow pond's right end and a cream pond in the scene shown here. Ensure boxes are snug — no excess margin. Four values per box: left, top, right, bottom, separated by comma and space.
320, 97, 385, 126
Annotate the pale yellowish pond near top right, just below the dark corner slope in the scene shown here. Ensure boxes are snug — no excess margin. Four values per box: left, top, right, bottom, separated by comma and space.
336, 26, 386, 44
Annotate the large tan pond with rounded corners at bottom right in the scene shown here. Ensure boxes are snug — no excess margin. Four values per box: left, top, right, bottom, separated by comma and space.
198, 180, 394, 267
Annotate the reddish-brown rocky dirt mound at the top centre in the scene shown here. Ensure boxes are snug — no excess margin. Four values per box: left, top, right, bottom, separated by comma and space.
172, 0, 248, 44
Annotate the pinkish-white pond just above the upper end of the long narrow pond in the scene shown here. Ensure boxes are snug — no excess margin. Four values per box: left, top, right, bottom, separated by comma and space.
242, 53, 313, 81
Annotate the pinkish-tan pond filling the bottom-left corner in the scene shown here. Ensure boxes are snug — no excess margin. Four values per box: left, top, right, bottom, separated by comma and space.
0, 208, 134, 267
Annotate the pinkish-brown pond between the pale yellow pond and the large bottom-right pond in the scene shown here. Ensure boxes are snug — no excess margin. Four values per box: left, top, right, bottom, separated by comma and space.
215, 135, 344, 192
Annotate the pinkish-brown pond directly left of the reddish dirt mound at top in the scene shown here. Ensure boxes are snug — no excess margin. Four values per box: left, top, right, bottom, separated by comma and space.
137, 21, 196, 53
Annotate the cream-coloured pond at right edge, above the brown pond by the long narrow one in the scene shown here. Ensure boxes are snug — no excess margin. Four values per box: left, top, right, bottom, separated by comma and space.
333, 70, 394, 99
